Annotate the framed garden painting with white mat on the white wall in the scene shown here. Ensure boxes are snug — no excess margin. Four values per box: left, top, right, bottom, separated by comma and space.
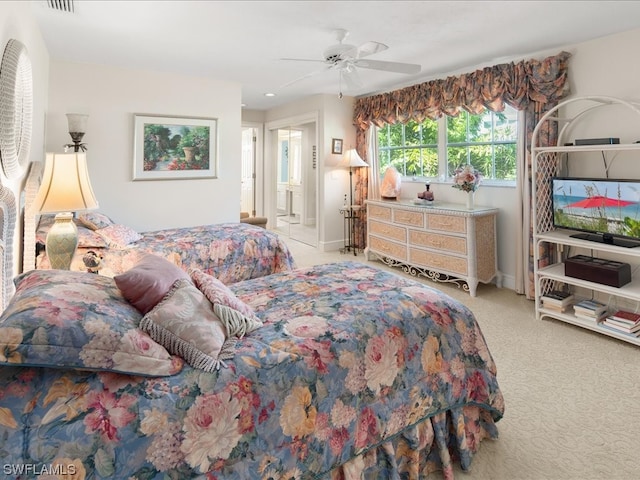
133, 114, 218, 180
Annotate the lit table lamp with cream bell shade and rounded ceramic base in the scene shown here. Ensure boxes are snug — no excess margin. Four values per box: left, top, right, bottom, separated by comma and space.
34, 153, 98, 270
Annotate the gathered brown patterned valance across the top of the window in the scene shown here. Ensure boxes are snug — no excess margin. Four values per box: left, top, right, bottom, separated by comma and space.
354, 52, 571, 131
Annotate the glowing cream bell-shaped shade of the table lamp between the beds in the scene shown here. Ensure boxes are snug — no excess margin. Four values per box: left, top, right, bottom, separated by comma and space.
34, 153, 98, 213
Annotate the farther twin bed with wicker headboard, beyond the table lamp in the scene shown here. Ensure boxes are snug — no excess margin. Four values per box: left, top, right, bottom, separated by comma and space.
23, 163, 295, 283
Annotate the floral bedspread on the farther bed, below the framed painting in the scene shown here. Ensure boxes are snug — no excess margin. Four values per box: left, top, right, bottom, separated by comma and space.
38, 223, 295, 284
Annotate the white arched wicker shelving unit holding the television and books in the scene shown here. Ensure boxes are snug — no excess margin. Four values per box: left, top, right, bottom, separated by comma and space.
532, 97, 640, 346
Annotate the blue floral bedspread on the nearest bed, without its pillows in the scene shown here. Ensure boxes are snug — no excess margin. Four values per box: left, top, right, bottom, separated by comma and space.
0, 262, 504, 480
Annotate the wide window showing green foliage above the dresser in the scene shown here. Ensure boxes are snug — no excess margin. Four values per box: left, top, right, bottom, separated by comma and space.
378, 105, 518, 181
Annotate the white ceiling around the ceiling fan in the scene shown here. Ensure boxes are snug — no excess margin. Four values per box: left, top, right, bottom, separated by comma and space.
32, 0, 640, 110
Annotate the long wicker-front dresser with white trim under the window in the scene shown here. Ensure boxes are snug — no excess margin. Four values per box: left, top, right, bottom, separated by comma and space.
365, 200, 500, 296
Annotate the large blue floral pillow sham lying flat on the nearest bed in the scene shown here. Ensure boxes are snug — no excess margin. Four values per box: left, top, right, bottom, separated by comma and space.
0, 270, 184, 376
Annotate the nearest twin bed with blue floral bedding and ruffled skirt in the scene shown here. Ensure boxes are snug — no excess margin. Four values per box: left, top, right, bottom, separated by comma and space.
0, 160, 504, 480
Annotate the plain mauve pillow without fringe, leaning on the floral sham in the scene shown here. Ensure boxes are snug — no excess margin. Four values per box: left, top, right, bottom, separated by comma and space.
113, 254, 191, 315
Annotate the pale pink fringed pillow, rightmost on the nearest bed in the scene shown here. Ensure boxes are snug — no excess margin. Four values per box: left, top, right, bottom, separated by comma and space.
189, 268, 262, 338
